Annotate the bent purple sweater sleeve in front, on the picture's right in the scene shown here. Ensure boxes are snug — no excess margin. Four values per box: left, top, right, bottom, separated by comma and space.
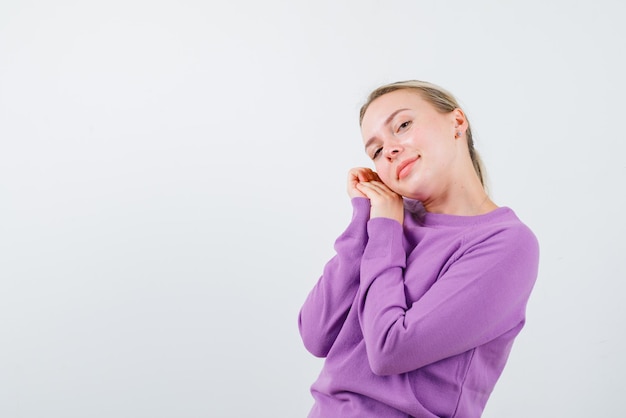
358, 218, 539, 375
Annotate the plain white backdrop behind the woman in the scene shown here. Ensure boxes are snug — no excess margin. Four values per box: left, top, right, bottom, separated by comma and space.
0, 0, 626, 418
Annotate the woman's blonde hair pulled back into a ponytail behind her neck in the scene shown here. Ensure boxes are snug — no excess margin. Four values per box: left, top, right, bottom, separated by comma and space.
359, 80, 485, 187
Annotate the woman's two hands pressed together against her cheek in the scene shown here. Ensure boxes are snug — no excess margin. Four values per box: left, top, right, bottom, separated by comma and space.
348, 167, 404, 223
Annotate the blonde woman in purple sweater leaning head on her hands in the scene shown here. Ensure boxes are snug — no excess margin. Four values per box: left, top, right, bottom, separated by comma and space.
299, 81, 539, 418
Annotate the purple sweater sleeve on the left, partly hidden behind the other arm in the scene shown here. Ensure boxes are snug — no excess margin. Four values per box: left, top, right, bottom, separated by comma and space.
298, 197, 370, 357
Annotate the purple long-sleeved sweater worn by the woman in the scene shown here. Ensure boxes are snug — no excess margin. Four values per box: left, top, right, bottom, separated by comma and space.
299, 198, 539, 418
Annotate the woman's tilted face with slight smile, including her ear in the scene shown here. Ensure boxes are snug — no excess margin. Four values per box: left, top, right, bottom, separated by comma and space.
361, 89, 466, 201
